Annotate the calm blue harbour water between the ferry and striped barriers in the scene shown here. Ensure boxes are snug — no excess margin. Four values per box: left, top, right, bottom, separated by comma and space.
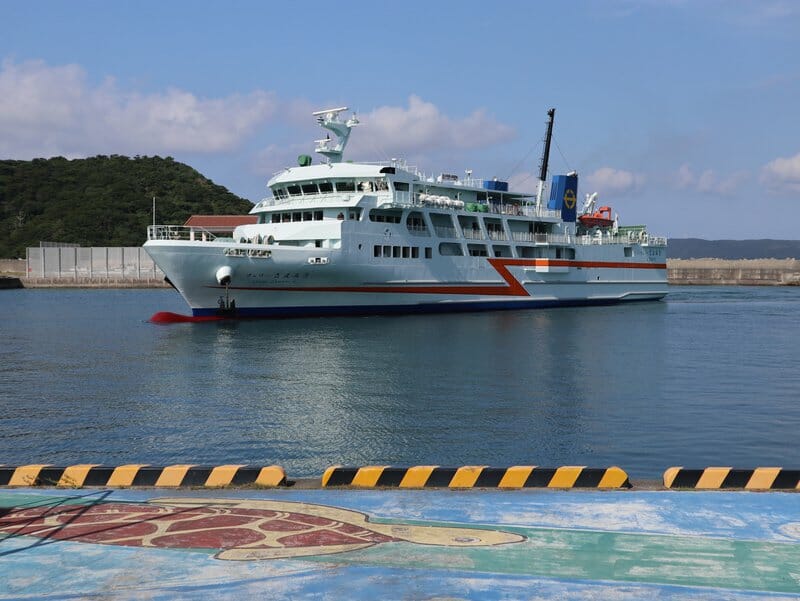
0, 287, 800, 478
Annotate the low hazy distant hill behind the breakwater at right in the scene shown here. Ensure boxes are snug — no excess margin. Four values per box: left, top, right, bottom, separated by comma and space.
667, 238, 800, 260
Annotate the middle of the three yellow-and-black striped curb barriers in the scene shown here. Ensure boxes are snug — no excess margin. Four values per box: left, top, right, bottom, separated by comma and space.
322, 465, 631, 488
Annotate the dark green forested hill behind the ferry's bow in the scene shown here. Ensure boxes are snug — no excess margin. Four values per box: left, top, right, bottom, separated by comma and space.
0, 155, 253, 258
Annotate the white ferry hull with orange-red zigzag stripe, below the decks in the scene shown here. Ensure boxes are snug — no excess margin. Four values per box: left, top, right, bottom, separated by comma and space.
145, 241, 667, 317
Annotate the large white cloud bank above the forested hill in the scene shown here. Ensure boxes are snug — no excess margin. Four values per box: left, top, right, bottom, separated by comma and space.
0, 60, 277, 158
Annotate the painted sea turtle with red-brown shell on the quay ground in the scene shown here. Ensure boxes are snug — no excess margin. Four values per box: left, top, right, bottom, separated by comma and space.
0, 499, 525, 560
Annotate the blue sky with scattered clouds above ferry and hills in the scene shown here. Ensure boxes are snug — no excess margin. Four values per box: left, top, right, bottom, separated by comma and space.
0, 0, 800, 239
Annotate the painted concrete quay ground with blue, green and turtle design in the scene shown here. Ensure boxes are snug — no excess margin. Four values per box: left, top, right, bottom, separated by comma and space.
0, 489, 800, 599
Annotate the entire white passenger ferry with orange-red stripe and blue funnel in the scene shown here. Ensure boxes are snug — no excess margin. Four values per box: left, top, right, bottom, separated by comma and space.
144, 107, 667, 319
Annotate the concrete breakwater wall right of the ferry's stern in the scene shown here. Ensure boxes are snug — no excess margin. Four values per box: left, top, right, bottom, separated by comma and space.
667, 259, 800, 286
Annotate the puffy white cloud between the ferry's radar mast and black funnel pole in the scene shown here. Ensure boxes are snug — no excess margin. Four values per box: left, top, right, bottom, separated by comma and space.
352, 95, 516, 156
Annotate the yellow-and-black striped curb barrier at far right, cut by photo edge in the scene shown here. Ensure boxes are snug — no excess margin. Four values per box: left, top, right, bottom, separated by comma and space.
664, 467, 800, 490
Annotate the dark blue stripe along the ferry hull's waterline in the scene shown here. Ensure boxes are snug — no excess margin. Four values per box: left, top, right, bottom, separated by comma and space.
192, 298, 660, 319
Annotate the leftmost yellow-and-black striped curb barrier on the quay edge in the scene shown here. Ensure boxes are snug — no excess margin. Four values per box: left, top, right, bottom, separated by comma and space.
0, 464, 286, 488
